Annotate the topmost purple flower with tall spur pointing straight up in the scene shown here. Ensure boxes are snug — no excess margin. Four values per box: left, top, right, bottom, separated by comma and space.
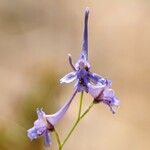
60, 8, 107, 93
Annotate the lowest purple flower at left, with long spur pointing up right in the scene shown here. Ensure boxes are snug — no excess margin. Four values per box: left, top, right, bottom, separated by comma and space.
27, 91, 77, 146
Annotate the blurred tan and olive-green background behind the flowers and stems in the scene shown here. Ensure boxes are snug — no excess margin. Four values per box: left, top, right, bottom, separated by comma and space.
0, 0, 150, 150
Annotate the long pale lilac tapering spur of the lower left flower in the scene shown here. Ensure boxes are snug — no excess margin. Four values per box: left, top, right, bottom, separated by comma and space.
46, 90, 77, 126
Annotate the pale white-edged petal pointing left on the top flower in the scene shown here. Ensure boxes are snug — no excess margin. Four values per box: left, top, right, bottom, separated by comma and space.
60, 72, 76, 83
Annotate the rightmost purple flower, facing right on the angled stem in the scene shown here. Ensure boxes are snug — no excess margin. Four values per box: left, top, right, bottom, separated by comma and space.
89, 82, 119, 114
